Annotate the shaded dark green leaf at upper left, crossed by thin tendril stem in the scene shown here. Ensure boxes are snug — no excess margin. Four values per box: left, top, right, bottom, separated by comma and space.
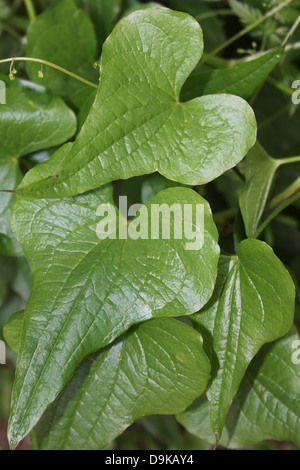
26, 0, 98, 97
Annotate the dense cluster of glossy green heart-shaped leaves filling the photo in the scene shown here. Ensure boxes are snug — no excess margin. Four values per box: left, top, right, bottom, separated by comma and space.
0, 0, 300, 450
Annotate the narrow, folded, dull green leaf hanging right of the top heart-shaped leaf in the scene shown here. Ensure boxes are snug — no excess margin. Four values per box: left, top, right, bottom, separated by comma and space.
239, 142, 280, 237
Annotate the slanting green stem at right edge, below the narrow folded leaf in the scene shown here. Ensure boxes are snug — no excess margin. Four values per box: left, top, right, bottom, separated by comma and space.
254, 176, 300, 238
